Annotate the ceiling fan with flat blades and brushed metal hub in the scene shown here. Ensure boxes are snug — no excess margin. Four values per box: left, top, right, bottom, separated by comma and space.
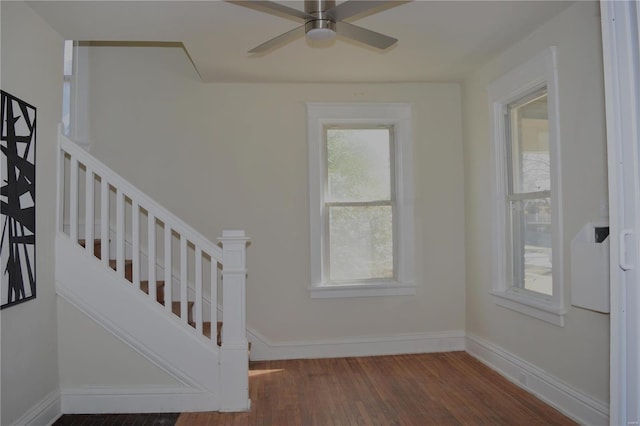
231, 0, 406, 53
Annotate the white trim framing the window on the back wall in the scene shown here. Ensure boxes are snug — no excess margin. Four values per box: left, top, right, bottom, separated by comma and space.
307, 103, 416, 298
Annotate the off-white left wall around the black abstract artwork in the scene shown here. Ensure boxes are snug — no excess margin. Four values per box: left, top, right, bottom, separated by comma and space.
0, 1, 63, 425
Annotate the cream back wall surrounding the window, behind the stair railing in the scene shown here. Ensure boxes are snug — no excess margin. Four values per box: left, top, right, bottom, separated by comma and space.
82, 47, 465, 352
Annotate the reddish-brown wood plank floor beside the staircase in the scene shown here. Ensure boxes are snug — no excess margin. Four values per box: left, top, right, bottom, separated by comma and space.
176, 352, 576, 426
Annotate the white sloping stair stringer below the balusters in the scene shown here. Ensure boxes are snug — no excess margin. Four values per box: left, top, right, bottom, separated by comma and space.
56, 233, 221, 412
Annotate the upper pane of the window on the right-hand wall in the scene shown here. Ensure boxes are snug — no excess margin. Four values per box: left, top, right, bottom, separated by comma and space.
508, 93, 551, 193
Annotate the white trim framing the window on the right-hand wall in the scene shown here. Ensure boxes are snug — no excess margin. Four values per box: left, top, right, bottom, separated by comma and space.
489, 46, 567, 327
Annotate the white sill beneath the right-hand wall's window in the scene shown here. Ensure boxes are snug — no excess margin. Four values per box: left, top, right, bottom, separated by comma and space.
490, 290, 567, 327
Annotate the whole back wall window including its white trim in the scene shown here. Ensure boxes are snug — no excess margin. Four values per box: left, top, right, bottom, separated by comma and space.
307, 104, 415, 298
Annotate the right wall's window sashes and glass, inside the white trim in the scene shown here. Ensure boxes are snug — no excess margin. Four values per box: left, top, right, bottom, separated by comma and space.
505, 87, 553, 296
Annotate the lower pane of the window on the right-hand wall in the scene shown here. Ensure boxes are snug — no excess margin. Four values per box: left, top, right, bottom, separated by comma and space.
511, 198, 553, 296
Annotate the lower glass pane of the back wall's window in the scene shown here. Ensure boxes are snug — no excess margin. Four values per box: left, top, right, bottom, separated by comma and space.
329, 206, 394, 281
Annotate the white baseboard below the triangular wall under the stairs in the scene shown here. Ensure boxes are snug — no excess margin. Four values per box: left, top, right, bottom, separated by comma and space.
61, 387, 220, 414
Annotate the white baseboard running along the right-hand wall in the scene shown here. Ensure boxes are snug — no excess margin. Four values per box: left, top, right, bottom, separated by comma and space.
466, 333, 609, 425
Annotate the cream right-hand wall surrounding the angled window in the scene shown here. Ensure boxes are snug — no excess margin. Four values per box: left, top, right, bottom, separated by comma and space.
463, 2, 609, 404
